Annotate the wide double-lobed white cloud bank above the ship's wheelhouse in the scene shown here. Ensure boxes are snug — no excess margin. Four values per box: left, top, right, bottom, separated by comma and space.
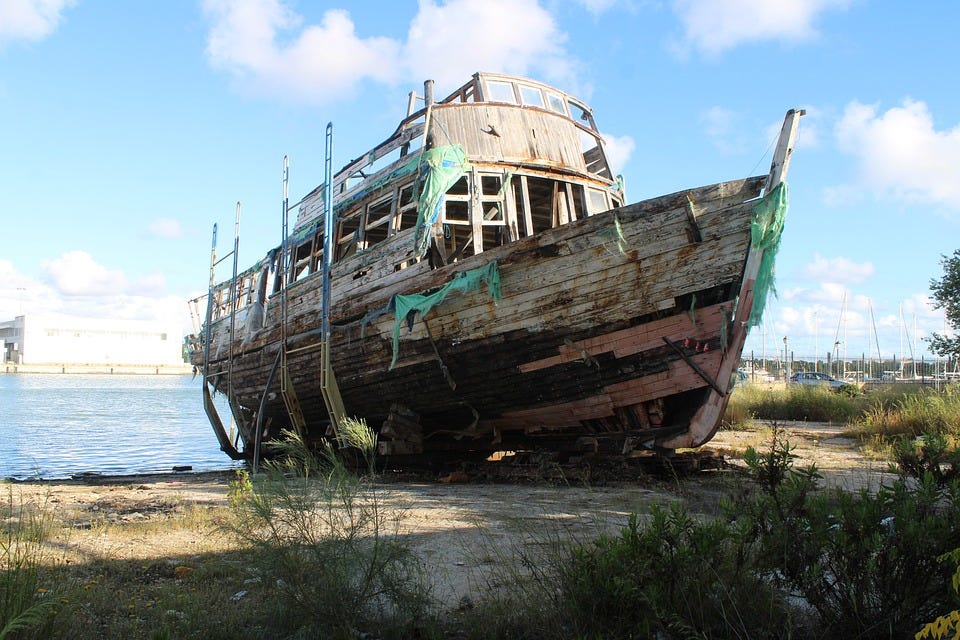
204, 0, 571, 103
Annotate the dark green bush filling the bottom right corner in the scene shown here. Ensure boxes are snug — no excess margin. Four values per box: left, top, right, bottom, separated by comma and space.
727, 432, 960, 638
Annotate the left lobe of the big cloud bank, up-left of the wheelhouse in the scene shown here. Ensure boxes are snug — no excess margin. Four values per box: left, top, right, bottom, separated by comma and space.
204, 0, 400, 103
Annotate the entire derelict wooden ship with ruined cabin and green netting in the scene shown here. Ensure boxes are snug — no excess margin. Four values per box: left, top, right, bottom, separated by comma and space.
191, 73, 802, 460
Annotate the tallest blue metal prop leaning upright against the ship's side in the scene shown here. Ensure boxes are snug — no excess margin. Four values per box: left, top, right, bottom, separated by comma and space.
320, 122, 346, 437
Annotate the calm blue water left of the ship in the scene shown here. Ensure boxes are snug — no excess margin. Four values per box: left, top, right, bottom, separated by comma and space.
0, 373, 236, 479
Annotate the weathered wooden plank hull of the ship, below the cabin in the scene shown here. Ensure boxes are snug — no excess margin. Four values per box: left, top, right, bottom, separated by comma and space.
209, 172, 765, 453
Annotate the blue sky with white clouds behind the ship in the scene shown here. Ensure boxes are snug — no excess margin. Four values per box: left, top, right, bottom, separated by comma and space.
0, 0, 960, 357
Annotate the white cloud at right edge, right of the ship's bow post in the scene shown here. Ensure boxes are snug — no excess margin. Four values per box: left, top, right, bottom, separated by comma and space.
831, 99, 960, 209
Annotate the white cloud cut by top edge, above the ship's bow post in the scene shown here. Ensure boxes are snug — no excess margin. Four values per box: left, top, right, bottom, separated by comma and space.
672, 0, 850, 55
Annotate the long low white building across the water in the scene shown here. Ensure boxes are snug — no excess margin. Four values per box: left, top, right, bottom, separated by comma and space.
0, 315, 183, 366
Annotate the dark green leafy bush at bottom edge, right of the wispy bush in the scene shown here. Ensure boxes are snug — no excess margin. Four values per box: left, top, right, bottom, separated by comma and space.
560, 504, 790, 638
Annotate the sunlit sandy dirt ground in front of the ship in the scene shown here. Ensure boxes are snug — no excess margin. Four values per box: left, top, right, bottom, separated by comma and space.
5, 423, 891, 605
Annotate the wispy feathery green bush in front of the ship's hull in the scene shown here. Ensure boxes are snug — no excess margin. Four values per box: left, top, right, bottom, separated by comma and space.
225, 423, 431, 638
